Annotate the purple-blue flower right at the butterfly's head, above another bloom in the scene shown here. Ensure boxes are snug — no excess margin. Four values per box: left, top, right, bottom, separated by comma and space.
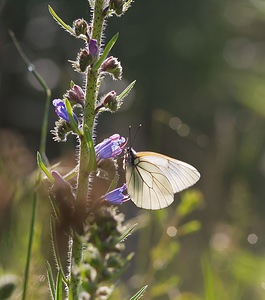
95, 134, 126, 160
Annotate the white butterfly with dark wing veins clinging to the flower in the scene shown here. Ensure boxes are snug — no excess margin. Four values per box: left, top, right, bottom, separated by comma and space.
124, 147, 200, 209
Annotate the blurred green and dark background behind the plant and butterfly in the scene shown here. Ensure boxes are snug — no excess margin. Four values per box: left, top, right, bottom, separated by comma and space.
0, 0, 265, 300
